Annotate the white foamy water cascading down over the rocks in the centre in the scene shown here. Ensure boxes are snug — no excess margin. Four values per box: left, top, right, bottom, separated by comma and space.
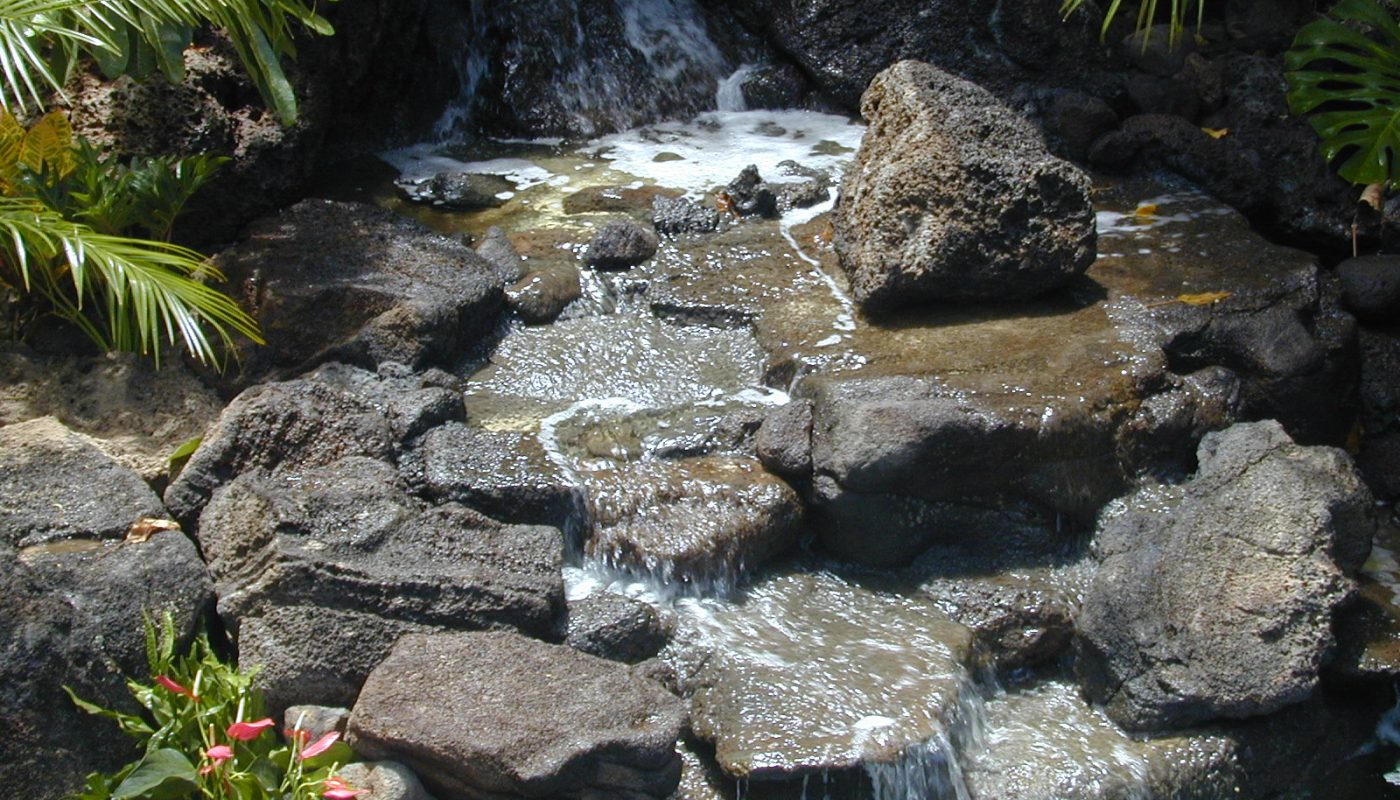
330, 0, 1400, 800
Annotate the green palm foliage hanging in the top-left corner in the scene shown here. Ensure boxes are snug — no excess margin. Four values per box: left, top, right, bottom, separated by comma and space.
0, 0, 335, 125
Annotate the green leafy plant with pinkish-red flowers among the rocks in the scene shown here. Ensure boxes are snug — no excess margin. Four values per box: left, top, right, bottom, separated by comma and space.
64, 614, 360, 800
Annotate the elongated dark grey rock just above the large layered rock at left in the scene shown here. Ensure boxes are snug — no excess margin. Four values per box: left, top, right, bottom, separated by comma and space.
165, 364, 465, 530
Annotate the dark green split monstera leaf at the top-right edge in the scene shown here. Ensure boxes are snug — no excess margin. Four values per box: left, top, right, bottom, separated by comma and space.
1284, 0, 1400, 185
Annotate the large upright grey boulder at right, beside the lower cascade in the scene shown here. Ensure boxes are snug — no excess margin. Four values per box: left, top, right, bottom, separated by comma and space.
1077, 422, 1375, 730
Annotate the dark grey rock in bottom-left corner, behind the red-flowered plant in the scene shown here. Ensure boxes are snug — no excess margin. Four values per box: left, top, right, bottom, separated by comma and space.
0, 531, 213, 800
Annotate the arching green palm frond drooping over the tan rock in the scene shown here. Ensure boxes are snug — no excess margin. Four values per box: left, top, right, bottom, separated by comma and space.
0, 198, 262, 366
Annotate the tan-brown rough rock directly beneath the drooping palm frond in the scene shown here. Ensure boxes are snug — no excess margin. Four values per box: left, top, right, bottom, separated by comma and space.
0, 345, 224, 483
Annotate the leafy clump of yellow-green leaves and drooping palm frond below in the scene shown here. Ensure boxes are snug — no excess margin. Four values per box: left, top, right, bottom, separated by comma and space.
0, 112, 260, 364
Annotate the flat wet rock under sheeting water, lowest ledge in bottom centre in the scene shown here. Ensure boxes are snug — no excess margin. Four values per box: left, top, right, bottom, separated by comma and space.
690, 573, 972, 782
